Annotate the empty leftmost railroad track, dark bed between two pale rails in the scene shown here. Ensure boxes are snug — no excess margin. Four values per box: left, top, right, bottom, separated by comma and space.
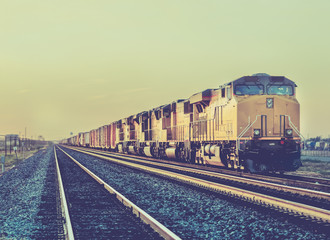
54, 148, 180, 239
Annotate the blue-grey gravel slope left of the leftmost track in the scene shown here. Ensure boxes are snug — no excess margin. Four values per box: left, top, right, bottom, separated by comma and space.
0, 147, 53, 239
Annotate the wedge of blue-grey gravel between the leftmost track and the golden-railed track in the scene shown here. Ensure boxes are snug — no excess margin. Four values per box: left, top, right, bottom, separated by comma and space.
63, 150, 329, 239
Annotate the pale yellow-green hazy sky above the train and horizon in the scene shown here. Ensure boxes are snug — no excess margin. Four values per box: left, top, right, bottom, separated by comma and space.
0, 0, 330, 140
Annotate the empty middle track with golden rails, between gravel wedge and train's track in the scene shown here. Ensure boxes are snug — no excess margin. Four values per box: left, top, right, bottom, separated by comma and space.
62, 145, 330, 226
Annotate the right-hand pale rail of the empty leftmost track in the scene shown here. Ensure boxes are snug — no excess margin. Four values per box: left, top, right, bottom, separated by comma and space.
58, 147, 181, 240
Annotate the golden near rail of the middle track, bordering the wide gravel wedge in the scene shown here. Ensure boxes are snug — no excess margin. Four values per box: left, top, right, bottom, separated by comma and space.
63, 146, 330, 224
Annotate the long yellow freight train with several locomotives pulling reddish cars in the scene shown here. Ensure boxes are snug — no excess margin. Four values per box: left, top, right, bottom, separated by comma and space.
62, 73, 302, 172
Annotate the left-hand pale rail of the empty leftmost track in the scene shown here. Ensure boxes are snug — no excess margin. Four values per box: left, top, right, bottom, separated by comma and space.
54, 146, 74, 240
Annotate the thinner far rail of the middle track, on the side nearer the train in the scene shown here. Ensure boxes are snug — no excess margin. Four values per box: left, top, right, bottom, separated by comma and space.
64, 146, 330, 201
